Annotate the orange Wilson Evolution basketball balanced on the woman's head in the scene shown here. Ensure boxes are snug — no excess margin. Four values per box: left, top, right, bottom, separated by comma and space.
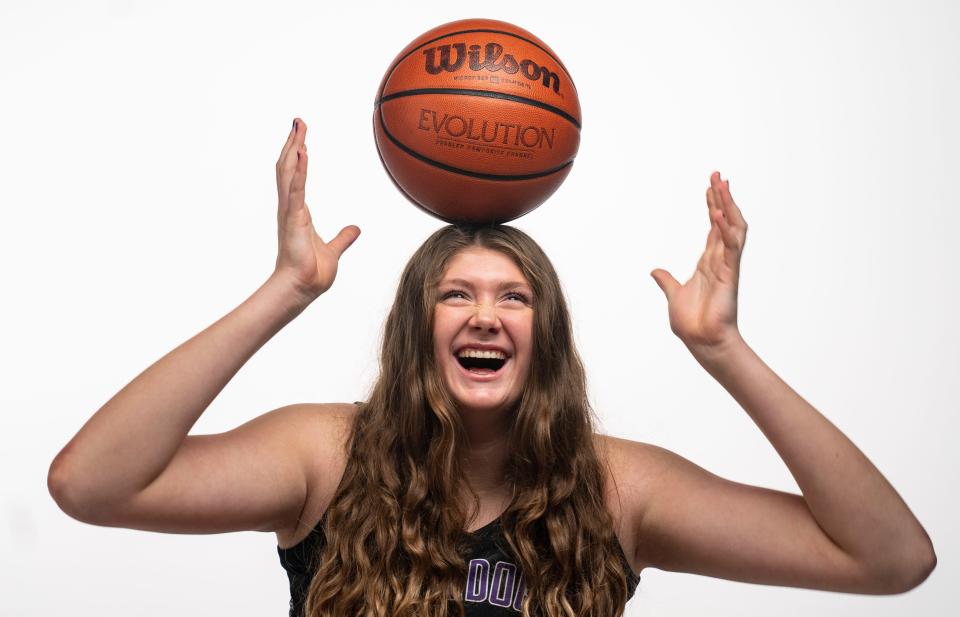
373, 19, 580, 223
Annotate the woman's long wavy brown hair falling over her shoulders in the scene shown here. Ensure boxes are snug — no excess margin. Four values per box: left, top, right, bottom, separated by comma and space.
305, 225, 627, 617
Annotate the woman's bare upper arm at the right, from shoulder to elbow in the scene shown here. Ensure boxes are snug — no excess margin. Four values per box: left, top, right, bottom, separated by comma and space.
619, 440, 879, 593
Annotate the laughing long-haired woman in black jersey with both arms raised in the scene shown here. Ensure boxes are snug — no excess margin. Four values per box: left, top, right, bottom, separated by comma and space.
49, 120, 936, 617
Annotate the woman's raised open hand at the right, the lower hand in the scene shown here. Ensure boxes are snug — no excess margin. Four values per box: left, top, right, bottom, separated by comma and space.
650, 172, 747, 353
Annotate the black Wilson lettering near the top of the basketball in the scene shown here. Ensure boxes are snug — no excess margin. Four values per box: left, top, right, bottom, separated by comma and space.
423, 43, 560, 93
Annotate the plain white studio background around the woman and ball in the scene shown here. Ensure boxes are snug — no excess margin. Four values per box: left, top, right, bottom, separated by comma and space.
0, 0, 960, 617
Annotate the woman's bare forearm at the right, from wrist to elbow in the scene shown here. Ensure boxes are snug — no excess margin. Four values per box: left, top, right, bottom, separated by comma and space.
691, 338, 933, 569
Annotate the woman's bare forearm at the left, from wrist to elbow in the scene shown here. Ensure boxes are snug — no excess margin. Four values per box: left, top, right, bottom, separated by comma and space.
48, 277, 306, 510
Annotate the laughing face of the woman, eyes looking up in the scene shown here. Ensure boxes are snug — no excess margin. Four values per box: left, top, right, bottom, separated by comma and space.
433, 246, 533, 415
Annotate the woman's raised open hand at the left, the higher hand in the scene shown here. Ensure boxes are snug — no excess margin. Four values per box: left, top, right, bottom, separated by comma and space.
274, 118, 360, 303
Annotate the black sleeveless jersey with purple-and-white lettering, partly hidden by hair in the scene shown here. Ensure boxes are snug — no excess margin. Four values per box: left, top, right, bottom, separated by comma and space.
277, 516, 640, 617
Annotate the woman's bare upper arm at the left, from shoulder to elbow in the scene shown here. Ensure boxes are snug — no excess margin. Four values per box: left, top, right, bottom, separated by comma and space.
91, 405, 346, 534
